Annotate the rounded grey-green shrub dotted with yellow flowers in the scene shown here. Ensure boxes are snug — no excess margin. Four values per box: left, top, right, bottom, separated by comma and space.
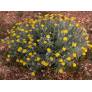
2, 14, 92, 76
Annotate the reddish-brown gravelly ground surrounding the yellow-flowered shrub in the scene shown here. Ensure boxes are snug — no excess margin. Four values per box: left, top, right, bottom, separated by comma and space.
0, 11, 92, 80
